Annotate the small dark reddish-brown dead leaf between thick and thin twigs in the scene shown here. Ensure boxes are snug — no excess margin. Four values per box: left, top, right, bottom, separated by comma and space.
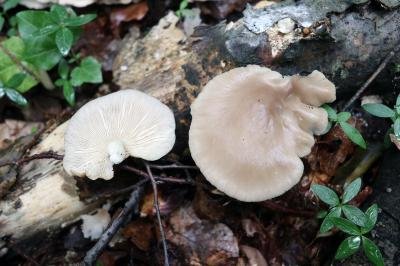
122, 220, 154, 251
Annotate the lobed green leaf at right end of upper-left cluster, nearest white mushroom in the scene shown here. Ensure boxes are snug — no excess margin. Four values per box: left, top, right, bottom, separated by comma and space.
71, 57, 103, 86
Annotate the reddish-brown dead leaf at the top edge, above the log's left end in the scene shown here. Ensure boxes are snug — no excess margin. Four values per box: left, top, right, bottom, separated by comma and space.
110, 1, 149, 29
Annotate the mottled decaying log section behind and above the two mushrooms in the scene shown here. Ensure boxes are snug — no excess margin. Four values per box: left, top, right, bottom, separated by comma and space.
113, 0, 400, 111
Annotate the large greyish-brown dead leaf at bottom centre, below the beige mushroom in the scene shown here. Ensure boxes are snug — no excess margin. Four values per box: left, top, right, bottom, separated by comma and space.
166, 206, 239, 265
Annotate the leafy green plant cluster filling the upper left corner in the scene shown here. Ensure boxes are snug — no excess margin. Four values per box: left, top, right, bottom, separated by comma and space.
0, 1, 102, 105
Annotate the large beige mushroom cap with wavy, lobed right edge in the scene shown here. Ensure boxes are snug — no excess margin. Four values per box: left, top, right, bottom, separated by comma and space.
189, 65, 336, 201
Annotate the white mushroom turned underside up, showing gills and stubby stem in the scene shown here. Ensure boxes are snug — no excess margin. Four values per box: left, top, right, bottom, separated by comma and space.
63, 90, 175, 180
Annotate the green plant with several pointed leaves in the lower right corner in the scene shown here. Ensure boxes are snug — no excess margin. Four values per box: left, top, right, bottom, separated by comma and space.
311, 178, 384, 266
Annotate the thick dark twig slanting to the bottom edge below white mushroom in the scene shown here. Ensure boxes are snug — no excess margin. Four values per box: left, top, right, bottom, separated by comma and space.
83, 179, 148, 266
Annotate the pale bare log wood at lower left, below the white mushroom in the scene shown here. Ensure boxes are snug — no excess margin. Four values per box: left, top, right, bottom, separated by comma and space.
0, 123, 100, 240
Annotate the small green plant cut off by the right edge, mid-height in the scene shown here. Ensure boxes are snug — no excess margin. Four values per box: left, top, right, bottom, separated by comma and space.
362, 95, 400, 141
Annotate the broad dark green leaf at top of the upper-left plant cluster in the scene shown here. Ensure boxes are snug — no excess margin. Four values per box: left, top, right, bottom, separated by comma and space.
17, 10, 55, 40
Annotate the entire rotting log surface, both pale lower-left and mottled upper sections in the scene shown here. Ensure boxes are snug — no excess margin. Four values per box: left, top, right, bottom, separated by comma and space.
0, 0, 400, 245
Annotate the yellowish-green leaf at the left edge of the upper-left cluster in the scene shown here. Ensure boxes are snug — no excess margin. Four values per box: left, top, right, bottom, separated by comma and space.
0, 37, 38, 92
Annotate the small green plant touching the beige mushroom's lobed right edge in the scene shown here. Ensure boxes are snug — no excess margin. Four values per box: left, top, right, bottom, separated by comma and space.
322, 104, 367, 149
